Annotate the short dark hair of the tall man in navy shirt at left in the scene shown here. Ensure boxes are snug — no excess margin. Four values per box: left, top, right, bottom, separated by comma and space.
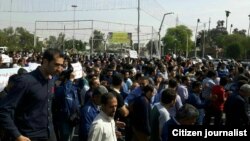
42, 48, 64, 63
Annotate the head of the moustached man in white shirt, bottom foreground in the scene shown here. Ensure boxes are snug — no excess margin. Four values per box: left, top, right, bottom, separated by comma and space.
101, 93, 117, 117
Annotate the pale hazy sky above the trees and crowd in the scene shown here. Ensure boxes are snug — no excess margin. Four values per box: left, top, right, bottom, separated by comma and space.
0, 0, 250, 41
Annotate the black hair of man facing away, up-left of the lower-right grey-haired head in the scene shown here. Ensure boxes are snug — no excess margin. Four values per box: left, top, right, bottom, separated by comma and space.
161, 88, 177, 104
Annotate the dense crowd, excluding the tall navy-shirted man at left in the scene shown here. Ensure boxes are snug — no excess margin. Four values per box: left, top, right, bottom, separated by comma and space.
0, 49, 250, 141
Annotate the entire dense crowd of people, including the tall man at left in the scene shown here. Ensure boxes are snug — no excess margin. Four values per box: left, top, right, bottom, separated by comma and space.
0, 48, 250, 141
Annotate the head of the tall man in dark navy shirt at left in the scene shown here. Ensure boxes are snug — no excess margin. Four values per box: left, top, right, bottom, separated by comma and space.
42, 48, 64, 75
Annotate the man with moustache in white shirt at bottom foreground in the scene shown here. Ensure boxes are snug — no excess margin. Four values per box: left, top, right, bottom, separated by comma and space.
88, 93, 117, 141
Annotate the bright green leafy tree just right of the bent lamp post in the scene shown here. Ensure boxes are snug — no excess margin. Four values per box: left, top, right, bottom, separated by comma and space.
162, 25, 194, 54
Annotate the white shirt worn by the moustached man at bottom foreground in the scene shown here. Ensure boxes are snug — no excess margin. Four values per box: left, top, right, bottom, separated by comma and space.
88, 111, 117, 141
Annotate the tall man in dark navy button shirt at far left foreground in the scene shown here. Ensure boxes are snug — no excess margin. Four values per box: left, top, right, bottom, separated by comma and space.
0, 49, 64, 141
